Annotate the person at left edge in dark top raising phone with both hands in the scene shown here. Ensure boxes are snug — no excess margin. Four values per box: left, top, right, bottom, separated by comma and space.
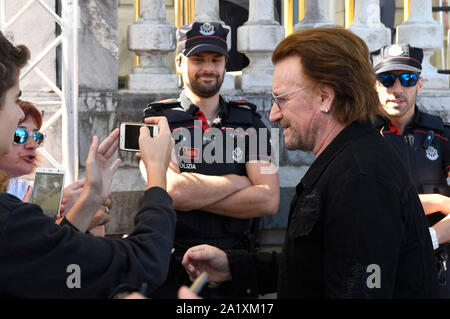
0, 33, 175, 298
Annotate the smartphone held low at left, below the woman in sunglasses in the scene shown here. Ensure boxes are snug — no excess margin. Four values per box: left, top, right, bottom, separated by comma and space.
31, 168, 65, 218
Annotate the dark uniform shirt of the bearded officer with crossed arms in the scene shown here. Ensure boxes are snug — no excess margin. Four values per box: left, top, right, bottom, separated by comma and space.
144, 91, 271, 250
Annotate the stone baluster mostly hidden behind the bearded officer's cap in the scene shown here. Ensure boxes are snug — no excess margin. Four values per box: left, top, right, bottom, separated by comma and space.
194, 0, 235, 90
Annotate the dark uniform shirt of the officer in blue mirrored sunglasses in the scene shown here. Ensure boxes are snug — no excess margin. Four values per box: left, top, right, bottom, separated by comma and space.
381, 106, 450, 226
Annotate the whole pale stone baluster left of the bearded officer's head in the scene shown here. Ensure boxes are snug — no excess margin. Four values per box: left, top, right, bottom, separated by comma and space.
128, 0, 178, 91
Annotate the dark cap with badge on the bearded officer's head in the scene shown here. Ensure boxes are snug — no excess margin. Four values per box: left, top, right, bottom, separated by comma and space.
177, 21, 229, 57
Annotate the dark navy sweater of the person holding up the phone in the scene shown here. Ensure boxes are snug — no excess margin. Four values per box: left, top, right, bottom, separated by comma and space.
0, 187, 175, 298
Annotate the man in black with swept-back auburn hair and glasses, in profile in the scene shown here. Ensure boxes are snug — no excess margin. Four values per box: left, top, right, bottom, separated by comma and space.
182, 28, 437, 298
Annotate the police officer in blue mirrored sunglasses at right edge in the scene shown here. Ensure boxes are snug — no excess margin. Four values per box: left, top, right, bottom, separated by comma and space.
371, 44, 450, 298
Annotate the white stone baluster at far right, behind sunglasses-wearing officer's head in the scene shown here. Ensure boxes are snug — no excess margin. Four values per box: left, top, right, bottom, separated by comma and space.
397, 0, 449, 89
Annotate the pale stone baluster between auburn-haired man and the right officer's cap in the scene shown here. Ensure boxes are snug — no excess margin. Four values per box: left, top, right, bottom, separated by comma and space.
349, 0, 391, 52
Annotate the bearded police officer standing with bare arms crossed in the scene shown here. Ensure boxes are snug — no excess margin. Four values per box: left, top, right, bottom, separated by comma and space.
144, 22, 280, 298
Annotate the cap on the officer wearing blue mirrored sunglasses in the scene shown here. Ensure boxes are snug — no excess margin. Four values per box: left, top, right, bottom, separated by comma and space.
370, 44, 423, 74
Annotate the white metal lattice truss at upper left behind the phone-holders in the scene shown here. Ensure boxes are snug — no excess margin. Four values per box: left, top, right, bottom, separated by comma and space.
0, 0, 79, 184
